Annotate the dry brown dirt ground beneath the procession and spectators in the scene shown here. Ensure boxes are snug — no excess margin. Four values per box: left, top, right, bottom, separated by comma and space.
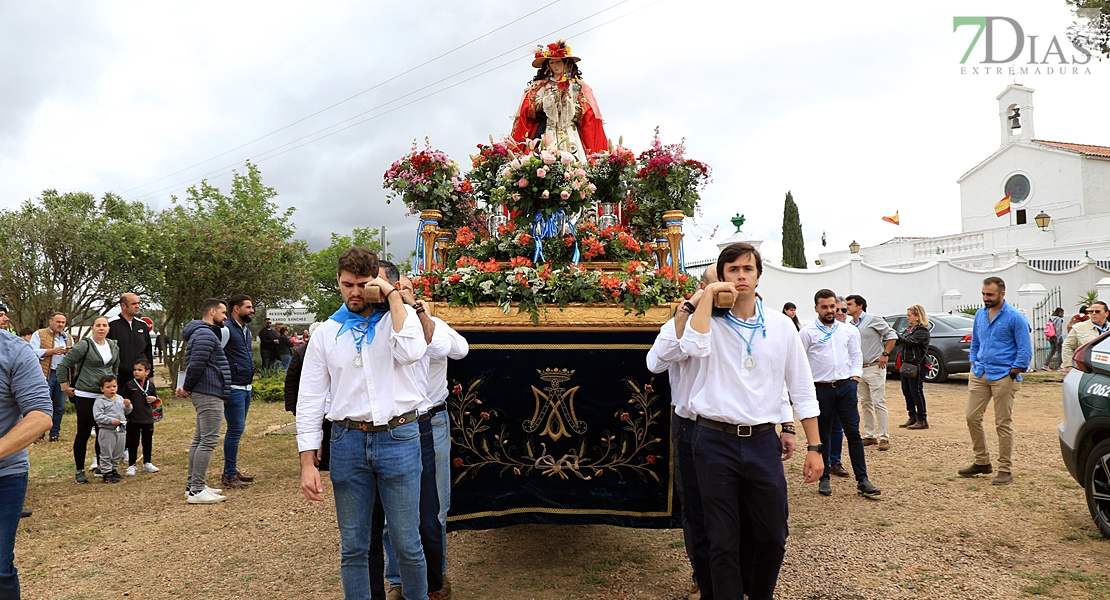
16, 374, 1110, 600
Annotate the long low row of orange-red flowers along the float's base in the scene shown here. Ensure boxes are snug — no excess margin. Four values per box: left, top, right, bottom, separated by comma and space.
413, 256, 698, 323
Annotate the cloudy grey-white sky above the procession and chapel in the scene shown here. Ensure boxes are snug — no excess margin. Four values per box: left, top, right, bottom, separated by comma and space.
0, 0, 1110, 261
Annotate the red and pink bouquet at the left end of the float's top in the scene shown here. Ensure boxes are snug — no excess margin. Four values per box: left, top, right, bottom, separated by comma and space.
382, 140, 480, 227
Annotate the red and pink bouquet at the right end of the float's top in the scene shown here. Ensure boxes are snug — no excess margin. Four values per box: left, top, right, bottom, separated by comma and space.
626, 128, 712, 240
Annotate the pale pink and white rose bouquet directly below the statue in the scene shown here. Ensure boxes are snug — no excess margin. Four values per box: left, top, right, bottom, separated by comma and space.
492, 135, 595, 224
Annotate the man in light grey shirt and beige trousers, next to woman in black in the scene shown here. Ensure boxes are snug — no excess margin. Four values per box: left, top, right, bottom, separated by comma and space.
848, 294, 898, 451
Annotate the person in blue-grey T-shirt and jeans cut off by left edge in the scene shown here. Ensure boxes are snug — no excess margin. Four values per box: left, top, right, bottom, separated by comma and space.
0, 330, 53, 599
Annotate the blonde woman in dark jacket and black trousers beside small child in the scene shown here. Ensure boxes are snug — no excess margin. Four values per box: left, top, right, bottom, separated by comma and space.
58, 317, 120, 484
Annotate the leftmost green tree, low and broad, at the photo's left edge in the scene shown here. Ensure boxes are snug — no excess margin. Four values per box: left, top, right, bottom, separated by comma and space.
0, 190, 162, 328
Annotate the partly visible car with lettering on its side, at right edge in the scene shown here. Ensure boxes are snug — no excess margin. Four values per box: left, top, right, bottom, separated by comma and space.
1058, 333, 1110, 538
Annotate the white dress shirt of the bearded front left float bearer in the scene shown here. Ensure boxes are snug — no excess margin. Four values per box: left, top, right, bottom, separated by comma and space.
296, 306, 427, 451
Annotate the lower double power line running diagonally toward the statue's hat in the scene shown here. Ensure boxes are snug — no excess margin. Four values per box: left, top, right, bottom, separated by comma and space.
131, 0, 665, 200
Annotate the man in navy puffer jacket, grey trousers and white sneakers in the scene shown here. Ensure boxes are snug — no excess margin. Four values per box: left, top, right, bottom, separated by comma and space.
174, 298, 231, 505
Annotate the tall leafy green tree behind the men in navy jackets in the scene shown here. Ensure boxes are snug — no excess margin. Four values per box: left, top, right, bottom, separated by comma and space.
159, 162, 311, 377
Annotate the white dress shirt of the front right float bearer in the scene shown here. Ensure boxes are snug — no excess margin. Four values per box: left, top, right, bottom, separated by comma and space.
680, 311, 820, 425
